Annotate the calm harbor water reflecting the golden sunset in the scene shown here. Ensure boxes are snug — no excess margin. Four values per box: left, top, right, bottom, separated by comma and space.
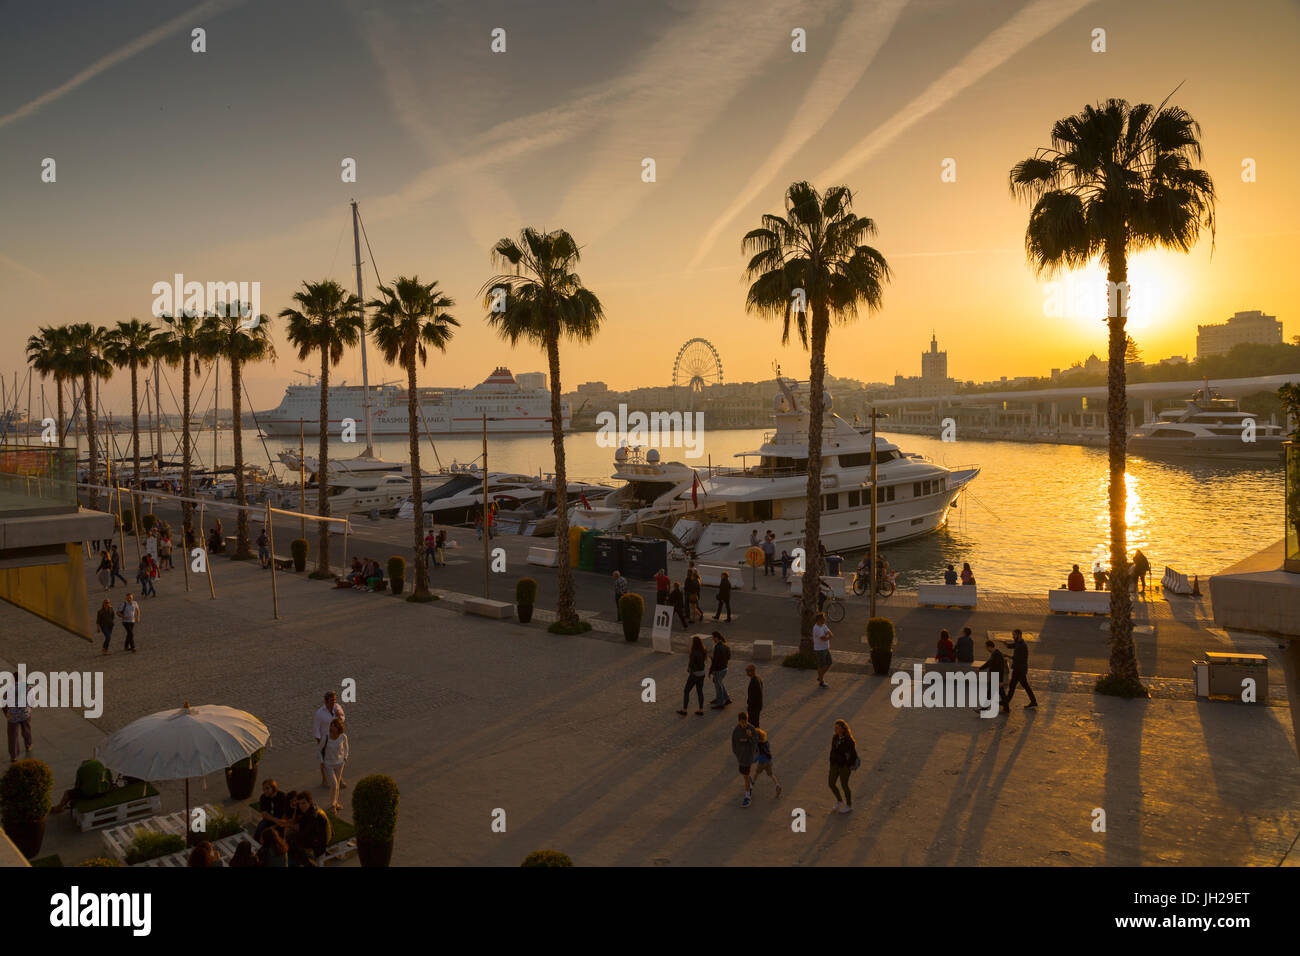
83, 429, 1283, 591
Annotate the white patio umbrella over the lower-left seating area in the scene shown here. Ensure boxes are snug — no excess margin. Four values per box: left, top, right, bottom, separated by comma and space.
95, 702, 270, 834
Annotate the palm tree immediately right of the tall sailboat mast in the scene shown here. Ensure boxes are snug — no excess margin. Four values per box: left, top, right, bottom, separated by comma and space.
367, 276, 460, 601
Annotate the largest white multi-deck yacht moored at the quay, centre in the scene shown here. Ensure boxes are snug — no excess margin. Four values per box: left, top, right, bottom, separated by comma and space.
672, 378, 979, 564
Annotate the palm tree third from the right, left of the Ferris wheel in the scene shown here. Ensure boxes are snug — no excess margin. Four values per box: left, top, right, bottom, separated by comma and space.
482, 228, 605, 628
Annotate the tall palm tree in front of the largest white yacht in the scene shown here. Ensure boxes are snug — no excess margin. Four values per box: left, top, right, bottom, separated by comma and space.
742, 182, 889, 657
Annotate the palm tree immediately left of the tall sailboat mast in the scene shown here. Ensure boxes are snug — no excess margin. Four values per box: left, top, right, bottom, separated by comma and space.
280, 278, 361, 578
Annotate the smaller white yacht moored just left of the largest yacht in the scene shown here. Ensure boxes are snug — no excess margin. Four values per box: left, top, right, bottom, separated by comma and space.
569, 445, 696, 535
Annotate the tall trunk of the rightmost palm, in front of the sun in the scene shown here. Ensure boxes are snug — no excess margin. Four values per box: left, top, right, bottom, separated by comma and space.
1106, 243, 1139, 684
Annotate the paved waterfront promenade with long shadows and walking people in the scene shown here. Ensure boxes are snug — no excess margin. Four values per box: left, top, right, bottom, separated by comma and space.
0, 523, 1300, 865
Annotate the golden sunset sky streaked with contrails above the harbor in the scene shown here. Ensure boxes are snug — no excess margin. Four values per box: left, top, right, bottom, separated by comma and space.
0, 0, 1300, 410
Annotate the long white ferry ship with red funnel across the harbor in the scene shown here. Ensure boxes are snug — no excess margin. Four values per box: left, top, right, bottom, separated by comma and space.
257, 367, 569, 437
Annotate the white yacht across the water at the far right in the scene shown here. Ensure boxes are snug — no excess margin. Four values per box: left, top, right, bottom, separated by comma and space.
1128, 382, 1286, 462
